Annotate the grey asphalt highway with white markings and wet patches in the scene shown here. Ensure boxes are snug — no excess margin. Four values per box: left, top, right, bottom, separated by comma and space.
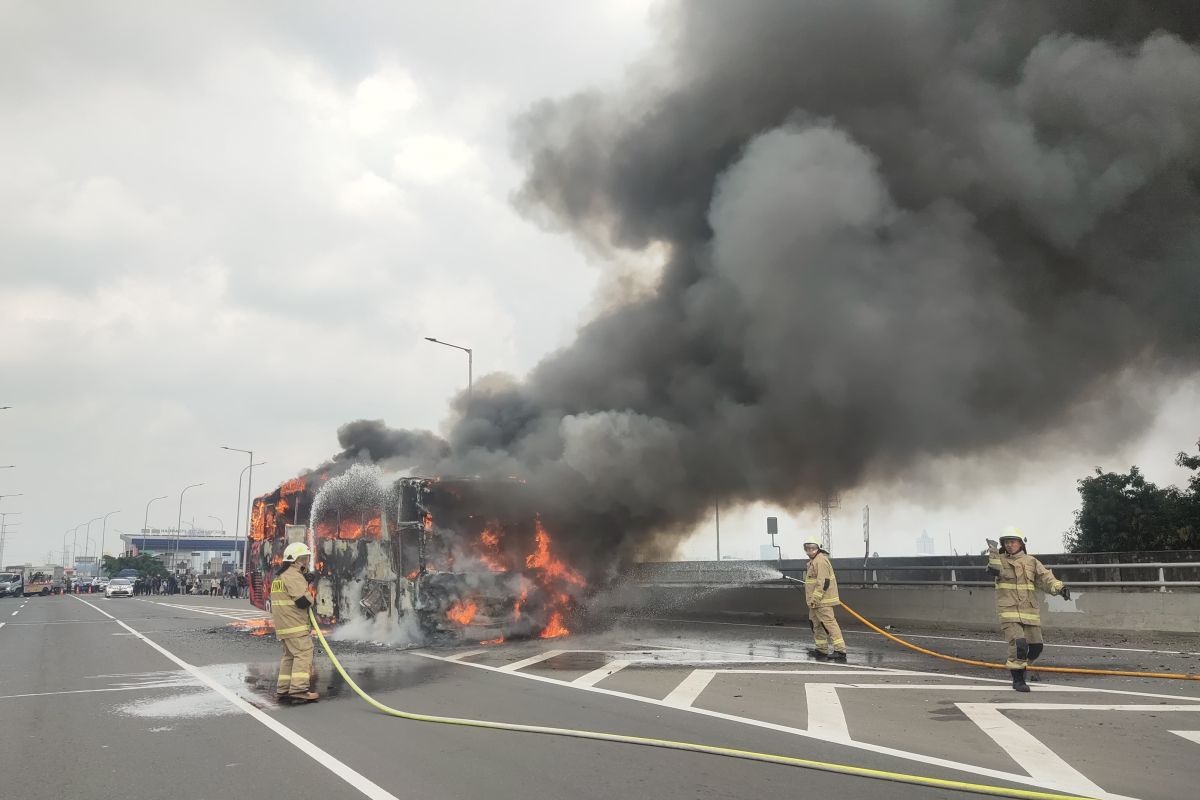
0, 596, 1200, 800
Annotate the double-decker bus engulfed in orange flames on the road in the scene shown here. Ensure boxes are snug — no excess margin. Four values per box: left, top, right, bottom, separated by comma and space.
246, 464, 587, 644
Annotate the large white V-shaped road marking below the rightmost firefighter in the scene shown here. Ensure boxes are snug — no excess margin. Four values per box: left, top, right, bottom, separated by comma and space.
955, 703, 1200, 794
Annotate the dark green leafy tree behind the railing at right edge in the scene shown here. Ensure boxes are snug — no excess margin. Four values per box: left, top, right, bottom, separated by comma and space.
1063, 441, 1200, 553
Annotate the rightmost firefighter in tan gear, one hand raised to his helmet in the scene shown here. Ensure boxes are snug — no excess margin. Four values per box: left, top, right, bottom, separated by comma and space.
988, 528, 1070, 692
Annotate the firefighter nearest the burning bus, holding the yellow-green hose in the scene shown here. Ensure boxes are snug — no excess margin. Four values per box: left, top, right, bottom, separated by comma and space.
271, 542, 320, 703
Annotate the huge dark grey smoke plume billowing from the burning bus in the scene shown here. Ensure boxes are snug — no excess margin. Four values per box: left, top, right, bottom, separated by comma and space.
350, 0, 1200, 573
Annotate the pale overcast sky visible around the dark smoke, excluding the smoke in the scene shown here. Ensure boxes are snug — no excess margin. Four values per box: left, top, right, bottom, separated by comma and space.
0, 0, 1200, 564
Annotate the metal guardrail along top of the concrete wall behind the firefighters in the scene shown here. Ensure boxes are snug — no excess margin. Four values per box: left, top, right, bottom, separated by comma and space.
640, 561, 1200, 593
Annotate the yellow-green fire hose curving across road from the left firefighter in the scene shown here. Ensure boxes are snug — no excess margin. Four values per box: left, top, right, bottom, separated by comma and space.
308, 608, 1094, 800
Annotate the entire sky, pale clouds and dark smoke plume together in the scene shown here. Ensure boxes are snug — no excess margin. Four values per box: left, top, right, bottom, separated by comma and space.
0, 1, 1200, 563
